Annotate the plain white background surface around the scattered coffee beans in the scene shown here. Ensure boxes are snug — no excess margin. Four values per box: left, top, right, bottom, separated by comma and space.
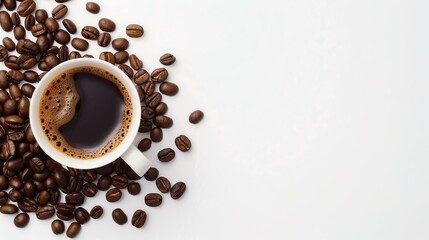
0, 0, 429, 240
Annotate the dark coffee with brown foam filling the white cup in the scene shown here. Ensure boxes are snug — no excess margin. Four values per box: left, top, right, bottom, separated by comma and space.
39, 66, 133, 159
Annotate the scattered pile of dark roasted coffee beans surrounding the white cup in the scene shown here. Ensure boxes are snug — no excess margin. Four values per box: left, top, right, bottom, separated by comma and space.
0, 0, 204, 238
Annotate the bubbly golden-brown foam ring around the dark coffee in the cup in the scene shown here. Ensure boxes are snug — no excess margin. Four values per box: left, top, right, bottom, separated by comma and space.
39, 67, 133, 159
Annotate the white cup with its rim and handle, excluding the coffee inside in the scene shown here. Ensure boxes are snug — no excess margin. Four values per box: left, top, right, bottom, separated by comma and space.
30, 58, 151, 176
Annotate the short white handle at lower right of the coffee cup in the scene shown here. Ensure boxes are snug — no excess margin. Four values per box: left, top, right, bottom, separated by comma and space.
121, 145, 152, 177
